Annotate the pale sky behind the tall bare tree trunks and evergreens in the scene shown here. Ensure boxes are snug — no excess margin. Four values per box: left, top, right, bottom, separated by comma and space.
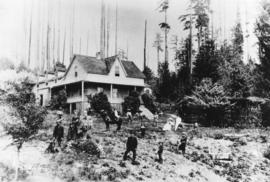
0, 0, 259, 72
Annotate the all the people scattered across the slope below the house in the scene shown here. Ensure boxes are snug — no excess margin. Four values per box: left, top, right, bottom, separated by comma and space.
47, 110, 187, 165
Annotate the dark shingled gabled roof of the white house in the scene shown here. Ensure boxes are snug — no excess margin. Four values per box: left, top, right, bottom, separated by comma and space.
71, 55, 145, 79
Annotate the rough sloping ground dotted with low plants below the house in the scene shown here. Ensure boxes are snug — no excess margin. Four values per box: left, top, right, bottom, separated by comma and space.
0, 113, 270, 182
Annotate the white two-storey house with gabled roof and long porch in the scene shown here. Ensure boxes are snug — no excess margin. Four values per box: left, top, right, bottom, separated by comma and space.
34, 55, 145, 112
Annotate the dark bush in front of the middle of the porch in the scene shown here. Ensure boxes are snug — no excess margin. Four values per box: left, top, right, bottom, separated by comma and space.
88, 92, 112, 113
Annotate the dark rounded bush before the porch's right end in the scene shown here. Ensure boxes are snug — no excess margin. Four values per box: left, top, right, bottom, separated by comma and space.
123, 91, 140, 114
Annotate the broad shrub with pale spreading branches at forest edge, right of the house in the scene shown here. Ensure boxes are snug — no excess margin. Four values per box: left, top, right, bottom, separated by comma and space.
177, 79, 230, 126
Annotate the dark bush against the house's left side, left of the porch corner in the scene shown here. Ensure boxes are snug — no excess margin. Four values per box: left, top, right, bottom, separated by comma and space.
50, 89, 67, 109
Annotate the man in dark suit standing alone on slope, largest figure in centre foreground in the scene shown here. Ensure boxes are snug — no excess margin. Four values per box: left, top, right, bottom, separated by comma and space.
123, 131, 138, 164
